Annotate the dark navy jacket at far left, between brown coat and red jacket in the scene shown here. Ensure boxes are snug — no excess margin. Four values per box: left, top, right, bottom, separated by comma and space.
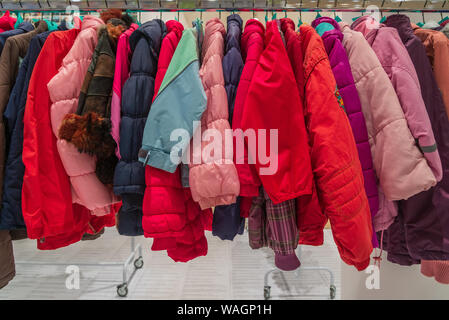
0, 27, 65, 230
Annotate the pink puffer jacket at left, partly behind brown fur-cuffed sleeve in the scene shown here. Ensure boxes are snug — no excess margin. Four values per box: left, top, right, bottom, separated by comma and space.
47, 16, 118, 216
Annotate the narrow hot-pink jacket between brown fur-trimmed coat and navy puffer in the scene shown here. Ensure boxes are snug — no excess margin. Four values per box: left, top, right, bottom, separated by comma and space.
111, 23, 139, 159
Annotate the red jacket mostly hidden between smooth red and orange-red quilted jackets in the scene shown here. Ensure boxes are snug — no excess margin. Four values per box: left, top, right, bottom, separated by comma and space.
281, 18, 328, 246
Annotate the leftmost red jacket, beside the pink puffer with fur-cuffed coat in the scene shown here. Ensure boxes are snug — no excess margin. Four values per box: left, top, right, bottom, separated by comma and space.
22, 28, 115, 249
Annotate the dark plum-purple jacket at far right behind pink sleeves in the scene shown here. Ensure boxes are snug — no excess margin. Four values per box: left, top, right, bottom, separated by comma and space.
384, 15, 449, 265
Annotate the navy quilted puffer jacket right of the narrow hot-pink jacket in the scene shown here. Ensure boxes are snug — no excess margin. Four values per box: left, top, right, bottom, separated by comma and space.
114, 19, 167, 236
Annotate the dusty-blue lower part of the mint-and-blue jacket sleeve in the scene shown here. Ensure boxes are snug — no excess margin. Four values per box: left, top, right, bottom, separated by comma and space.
139, 60, 206, 173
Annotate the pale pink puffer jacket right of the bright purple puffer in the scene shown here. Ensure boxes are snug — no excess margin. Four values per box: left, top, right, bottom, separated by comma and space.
340, 22, 436, 231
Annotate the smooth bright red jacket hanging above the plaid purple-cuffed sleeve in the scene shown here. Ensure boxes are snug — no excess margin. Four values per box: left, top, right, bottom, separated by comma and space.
241, 21, 313, 204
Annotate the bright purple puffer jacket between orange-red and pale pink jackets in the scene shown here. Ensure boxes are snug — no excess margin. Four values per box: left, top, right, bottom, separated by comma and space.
312, 17, 379, 247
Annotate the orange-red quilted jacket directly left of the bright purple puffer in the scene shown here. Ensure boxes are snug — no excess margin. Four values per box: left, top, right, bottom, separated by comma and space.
293, 25, 373, 270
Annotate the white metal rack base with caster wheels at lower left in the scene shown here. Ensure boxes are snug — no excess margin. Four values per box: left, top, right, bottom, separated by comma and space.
16, 237, 143, 297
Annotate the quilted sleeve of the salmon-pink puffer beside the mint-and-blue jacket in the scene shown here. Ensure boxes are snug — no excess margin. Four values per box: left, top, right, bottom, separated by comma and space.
189, 44, 240, 210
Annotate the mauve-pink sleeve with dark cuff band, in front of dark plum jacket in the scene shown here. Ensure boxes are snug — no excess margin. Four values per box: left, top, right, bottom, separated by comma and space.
380, 32, 443, 181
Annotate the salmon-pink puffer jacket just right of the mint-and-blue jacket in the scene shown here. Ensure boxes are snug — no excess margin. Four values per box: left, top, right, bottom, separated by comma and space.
189, 18, 240, 210
